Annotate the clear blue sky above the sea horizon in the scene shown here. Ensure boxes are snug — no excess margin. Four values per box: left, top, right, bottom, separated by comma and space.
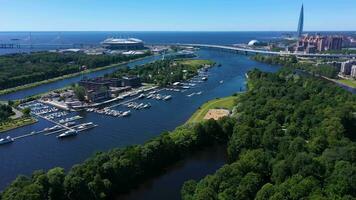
0, 0, 356, 31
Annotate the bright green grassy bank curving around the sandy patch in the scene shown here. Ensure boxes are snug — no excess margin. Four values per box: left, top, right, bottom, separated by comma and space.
187, 96, 238, 123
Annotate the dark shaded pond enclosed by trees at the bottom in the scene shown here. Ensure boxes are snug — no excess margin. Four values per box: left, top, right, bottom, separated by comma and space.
117, 146, 227, 200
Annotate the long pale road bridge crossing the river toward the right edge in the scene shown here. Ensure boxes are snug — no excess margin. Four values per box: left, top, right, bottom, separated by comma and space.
176, 44, 356, 58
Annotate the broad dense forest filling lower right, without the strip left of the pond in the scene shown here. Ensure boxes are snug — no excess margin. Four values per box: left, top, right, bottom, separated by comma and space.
181, 69, 356, 200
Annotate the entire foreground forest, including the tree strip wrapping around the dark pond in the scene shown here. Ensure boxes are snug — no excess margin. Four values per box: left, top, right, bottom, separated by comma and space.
1, 68, 356, 200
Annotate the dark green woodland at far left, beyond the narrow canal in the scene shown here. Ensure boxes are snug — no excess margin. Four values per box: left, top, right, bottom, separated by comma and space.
0, 52, 147, 90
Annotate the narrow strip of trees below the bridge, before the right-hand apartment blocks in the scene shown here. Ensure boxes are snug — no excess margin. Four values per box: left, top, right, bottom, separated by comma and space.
252, 55, 339, 78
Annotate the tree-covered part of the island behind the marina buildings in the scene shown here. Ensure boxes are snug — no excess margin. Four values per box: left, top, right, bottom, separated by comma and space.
110, 59, 213, 86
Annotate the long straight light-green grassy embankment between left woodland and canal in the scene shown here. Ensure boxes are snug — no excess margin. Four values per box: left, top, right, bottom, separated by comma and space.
0, 55, 152, 95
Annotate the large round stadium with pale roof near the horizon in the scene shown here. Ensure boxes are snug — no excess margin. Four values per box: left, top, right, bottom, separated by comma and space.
101, 38, 145, 51
